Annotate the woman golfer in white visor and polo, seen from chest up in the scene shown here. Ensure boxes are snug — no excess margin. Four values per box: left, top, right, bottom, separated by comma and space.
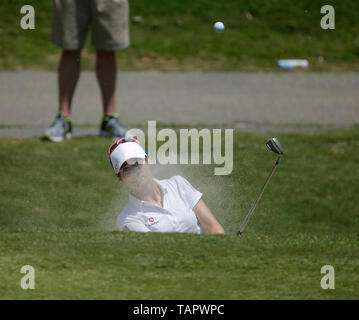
108, 137, 224, 233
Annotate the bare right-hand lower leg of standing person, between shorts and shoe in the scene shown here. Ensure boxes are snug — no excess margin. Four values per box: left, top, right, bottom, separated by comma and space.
96, 50, 117, 116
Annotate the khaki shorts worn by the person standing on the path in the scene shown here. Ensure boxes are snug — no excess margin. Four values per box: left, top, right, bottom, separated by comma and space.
51, 0, 130, 51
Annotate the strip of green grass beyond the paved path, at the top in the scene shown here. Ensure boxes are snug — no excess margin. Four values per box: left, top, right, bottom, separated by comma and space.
0, 0, 359, 71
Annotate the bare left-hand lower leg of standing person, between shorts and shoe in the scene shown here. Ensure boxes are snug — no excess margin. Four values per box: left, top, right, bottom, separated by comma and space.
58, 49, 81, 118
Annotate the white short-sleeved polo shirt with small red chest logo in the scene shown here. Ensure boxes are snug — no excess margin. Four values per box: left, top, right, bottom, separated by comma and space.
117, 176, 202, 233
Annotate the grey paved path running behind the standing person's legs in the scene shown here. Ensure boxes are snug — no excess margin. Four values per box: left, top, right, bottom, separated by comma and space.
0, 72, 359, 136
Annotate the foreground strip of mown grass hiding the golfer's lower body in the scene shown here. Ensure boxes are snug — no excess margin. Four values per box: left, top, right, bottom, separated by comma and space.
0, 231, 359, 299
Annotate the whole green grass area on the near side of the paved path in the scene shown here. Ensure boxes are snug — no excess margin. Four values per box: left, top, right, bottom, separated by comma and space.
0, 127, 359, 299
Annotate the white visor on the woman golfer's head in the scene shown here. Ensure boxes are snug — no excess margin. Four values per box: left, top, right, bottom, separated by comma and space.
110, 142, 147, 174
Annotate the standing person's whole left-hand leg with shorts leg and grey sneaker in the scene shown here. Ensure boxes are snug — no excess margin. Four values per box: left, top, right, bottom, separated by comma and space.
43, 0, 91, 142
